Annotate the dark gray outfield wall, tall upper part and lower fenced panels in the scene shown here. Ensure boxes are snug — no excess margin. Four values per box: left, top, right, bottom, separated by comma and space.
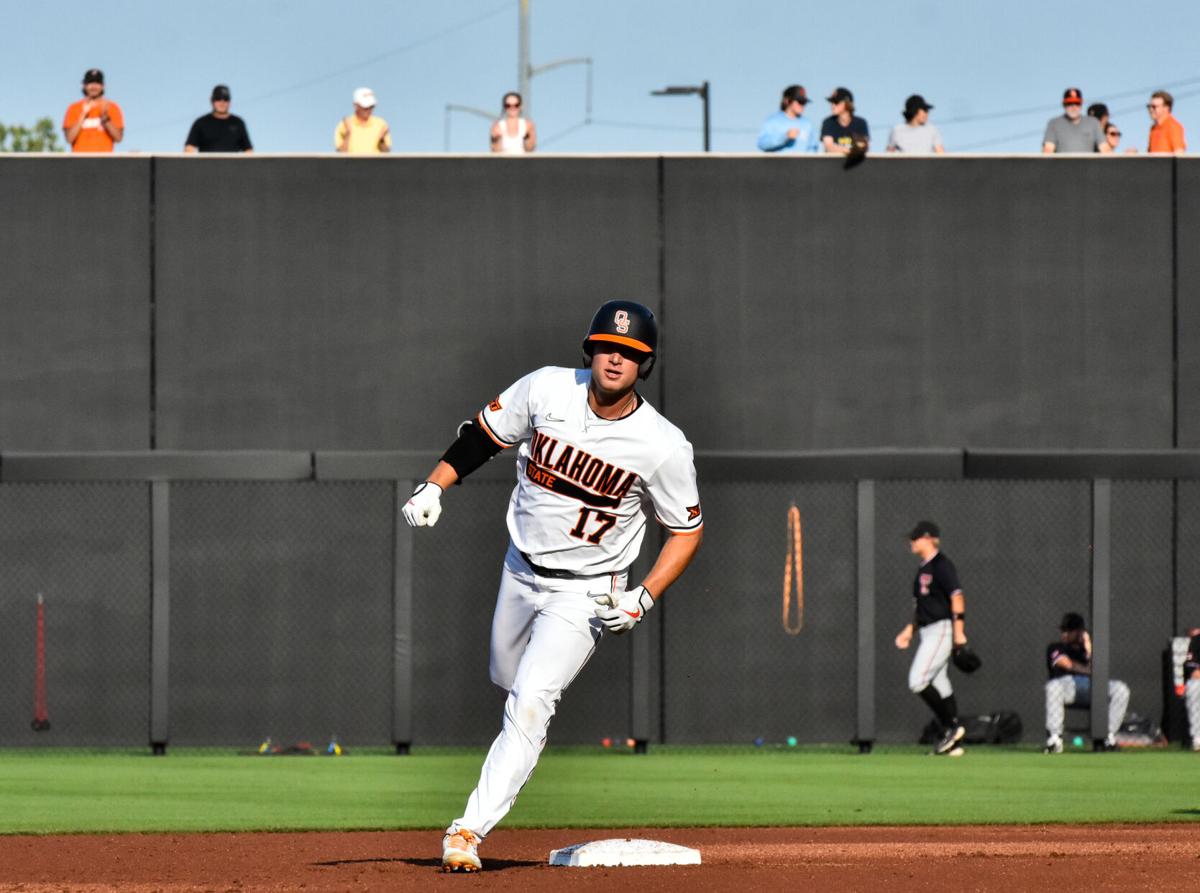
0, 156, 1200, 744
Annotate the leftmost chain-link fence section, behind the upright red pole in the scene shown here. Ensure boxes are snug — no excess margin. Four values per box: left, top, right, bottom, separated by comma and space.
0, 484, 150, 747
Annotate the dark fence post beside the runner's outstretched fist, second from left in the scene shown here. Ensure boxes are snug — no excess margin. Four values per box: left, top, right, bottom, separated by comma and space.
391, 480, 415, 754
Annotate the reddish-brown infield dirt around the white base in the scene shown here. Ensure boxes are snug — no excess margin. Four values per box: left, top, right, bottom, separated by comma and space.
0, 822, 1200, 893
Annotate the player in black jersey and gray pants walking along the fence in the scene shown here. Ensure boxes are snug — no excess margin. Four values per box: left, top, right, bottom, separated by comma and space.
895, 521, 967, 756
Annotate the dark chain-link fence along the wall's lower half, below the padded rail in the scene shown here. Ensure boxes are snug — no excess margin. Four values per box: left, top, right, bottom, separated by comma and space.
0, 468, 1200, 748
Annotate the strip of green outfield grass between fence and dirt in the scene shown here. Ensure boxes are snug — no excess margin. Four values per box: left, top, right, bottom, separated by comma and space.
0, 747, 1200, 833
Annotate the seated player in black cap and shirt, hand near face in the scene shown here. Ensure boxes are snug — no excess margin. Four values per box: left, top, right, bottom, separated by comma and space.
1045, 611, 1129, 754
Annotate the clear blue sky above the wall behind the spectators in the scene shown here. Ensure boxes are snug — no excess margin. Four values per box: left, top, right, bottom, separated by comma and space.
0, 0, 1200, 152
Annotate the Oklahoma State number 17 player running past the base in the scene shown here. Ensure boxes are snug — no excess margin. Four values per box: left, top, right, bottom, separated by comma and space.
403, 301, 703, 871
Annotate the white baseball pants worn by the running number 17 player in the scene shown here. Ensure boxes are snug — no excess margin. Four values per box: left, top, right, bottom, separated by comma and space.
449, 544, 626, 838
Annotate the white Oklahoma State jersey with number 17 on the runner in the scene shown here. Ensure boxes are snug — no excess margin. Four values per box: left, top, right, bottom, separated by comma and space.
478, 366, 703, 576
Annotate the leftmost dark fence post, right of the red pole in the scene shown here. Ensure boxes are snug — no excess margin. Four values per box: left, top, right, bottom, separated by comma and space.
150, 480, 170, 756
